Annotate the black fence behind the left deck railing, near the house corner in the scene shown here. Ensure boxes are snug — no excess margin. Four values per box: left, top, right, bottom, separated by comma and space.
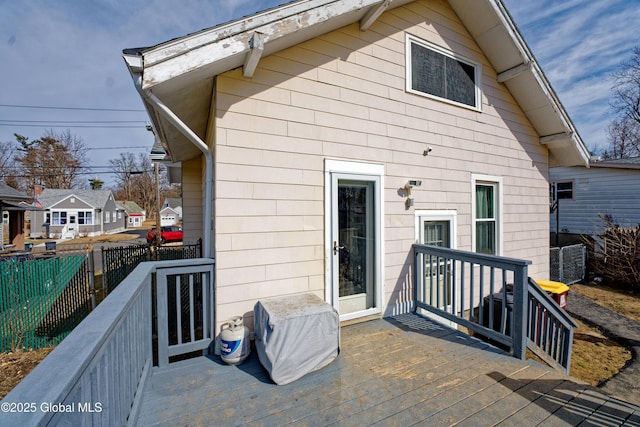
101, 239, 202, 297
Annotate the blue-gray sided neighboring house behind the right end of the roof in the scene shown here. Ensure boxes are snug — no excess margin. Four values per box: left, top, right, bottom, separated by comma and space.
549, 158, 640, 235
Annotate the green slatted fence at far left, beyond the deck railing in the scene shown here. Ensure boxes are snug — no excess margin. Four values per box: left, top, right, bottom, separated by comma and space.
0, 250, 95, 352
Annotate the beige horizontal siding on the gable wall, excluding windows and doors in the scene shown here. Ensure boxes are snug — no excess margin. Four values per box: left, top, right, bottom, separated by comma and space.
209, 1, 549, 328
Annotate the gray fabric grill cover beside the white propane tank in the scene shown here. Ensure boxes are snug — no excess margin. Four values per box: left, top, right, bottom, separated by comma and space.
253, 294, 340, 385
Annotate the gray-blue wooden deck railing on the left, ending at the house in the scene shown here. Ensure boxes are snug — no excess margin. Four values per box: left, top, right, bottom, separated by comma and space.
0, 258, 214, 426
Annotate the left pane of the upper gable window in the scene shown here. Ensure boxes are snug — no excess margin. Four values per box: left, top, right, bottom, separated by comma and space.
411, 43, 446, 98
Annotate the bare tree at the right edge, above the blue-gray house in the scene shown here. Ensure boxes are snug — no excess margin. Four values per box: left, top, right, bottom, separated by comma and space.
605, 47, 640, 159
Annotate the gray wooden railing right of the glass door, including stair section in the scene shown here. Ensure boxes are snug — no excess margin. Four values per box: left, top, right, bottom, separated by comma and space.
414, 244, 575, 370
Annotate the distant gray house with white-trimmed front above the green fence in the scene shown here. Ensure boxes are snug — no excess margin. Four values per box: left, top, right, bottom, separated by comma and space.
31, 188, 125, 239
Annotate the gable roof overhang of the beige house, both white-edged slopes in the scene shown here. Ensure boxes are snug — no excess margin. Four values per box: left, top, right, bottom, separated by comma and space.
123, 0, 589, 166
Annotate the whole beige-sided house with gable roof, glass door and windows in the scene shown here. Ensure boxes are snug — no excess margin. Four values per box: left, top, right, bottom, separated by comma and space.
124, 0, 589, 332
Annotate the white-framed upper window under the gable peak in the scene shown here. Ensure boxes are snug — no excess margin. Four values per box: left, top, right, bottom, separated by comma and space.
406, 35, 481, 110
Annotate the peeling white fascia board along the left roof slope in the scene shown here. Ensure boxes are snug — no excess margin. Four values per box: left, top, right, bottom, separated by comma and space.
142, 0, 380, 89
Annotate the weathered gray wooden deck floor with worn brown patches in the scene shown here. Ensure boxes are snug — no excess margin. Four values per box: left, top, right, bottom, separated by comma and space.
136, 315, 640, 426
